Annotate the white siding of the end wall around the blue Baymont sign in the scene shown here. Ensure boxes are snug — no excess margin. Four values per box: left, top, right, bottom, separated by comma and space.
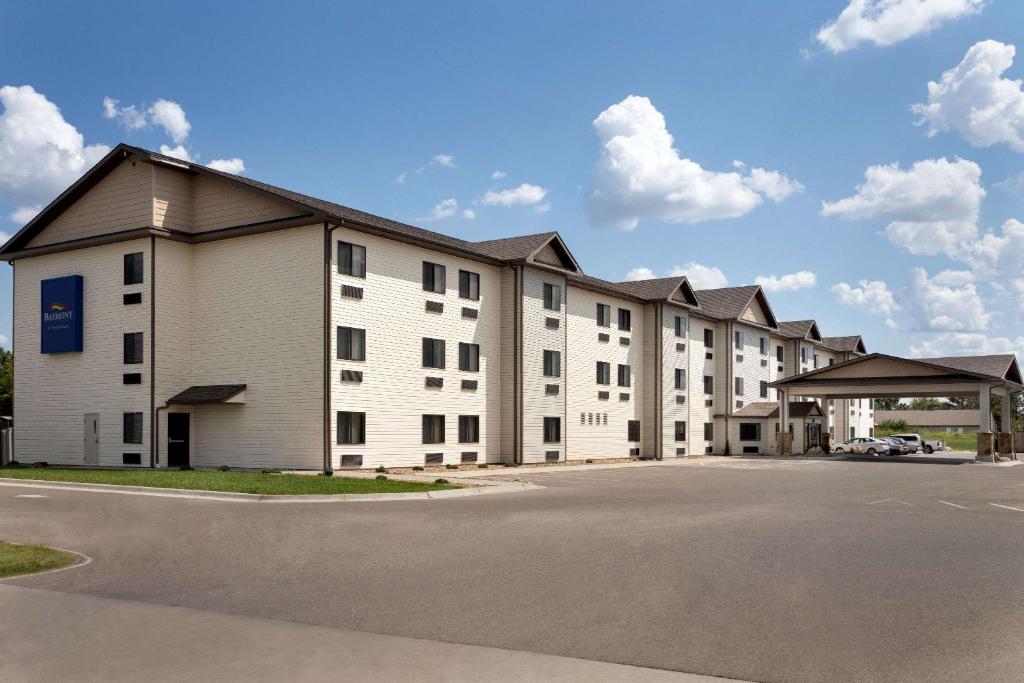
14, 239, 152, 465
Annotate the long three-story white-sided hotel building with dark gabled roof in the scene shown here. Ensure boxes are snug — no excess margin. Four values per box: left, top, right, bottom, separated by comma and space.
0, 145, 872, 470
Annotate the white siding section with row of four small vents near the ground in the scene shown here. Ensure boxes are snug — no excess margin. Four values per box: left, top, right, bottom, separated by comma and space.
565, 287, 653, 460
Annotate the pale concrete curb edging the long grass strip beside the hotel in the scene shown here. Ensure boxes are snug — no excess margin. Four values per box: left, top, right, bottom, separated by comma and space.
0, 478, 544, 505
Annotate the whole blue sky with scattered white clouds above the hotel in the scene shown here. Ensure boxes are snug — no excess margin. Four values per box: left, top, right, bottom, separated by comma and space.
0, 0, 1024, 354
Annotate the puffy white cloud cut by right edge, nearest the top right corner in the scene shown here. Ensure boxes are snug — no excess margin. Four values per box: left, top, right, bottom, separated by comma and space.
912, 40, 1024, 152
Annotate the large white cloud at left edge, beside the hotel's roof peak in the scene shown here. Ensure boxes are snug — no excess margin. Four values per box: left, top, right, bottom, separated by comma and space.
0, 85, 111, 208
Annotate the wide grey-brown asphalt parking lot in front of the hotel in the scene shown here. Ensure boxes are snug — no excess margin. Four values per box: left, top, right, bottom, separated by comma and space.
0, 459, 1024, 681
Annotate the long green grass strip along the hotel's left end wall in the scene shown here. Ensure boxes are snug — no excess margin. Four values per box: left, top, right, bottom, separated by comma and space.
0, 467, 458, 496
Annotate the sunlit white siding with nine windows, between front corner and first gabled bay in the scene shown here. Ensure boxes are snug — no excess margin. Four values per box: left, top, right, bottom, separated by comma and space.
331, 228, 501, 467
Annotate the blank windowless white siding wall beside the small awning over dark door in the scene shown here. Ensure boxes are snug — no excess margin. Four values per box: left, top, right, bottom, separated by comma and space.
189, 225, 324, 469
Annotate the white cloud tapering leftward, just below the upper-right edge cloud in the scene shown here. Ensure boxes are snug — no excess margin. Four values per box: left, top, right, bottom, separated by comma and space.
821, 158, 985, 256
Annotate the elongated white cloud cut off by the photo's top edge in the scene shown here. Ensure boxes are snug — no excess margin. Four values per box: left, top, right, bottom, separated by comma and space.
817, 0, 986, 52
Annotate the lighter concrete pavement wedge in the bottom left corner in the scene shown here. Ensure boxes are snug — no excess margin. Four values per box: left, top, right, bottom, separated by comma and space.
0, 584, 726, 683
